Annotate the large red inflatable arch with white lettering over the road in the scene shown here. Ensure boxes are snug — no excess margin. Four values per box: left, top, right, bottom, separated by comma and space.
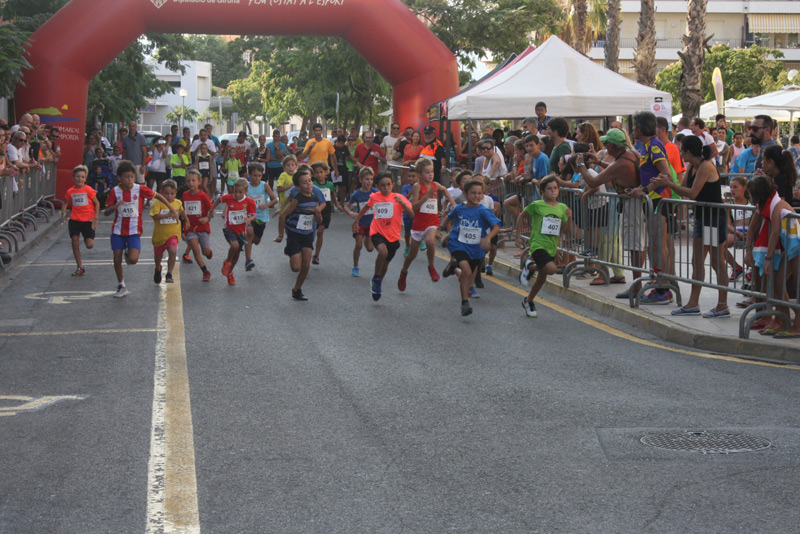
15, 0, 458, 196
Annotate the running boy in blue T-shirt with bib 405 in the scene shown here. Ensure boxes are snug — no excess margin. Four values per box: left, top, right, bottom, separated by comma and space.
440, 180, 500, 315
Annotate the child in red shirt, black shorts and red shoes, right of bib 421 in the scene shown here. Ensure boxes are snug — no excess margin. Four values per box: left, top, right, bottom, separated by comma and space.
211, 178, 256, 286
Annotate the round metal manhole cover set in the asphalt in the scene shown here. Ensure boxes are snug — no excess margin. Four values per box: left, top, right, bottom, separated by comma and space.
641, 431, 772, 454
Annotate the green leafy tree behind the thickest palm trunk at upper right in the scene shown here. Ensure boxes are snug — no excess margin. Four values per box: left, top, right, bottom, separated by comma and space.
656, 44, 788, 114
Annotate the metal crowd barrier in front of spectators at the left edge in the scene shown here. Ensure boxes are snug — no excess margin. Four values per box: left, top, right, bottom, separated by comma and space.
0, 163, 56, 268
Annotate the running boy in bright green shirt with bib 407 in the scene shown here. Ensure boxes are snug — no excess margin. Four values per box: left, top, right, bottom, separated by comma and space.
516, 175, 572, 317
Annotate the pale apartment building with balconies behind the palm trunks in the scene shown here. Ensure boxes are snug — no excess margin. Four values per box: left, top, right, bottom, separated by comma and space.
588, 0, 800, 79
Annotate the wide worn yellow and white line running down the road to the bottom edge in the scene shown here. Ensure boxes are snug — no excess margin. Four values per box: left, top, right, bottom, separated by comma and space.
147, 269, 200, 533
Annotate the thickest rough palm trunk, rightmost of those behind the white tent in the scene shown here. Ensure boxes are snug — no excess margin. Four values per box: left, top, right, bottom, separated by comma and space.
678, 0, 710, 118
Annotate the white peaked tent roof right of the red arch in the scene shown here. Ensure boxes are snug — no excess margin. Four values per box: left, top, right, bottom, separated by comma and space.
443, 36, 672, 120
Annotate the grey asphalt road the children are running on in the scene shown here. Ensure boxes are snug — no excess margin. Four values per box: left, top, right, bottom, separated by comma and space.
0, 211, 800, 534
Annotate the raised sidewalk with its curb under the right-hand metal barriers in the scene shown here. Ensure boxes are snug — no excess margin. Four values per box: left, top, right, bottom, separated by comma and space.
495, 243, 800, 363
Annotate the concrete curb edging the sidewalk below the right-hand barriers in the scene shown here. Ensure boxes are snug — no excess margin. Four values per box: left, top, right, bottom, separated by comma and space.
494, 258, 800, 364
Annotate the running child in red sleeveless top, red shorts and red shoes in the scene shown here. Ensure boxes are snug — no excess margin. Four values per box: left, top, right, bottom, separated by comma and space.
397, 158, 454, 291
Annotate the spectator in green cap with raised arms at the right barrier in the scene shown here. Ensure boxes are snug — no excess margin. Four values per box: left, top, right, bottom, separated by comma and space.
575, 128, 647, 298
